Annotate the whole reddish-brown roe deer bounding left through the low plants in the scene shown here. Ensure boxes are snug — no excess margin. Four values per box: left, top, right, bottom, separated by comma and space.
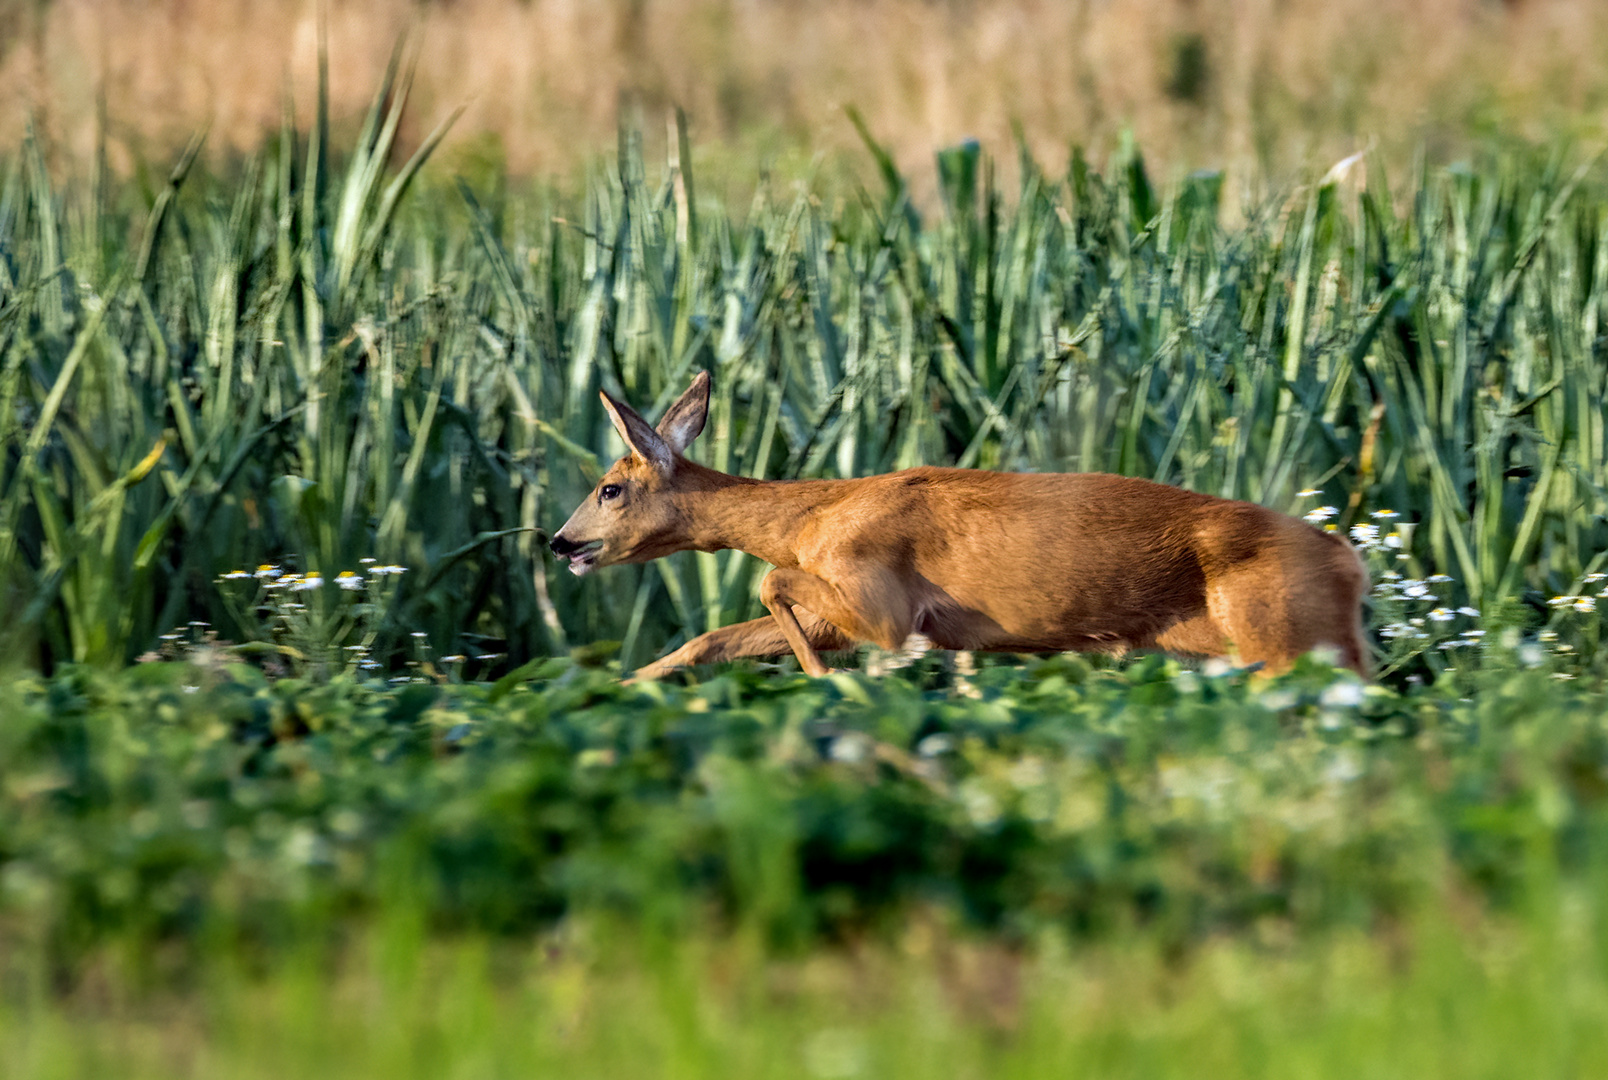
550, 373, 1368, 678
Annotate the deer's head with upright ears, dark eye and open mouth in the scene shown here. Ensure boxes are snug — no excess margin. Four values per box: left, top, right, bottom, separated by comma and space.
548, 371, 709, 575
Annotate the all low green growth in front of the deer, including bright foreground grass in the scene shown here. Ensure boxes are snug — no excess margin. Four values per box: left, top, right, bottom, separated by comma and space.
9, 657, 1608, 1077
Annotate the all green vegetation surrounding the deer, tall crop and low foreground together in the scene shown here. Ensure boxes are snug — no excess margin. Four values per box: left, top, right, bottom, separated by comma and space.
0, 42, 1608, 1077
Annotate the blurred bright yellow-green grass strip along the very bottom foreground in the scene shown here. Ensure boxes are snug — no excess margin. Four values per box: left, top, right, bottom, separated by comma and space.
9, 895, 1608, 1080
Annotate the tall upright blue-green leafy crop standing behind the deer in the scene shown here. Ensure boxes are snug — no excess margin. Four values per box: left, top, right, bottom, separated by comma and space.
0, 59, 1608, 673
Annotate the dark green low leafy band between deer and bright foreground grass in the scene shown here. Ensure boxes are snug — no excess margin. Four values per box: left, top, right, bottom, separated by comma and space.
0, 657, 1608, 964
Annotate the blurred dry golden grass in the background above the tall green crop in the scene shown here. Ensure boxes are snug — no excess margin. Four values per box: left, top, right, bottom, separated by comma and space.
0, 0, 1608, 185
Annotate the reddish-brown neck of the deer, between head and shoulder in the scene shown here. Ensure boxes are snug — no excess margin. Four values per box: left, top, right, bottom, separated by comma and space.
675, 461, 841, 567
